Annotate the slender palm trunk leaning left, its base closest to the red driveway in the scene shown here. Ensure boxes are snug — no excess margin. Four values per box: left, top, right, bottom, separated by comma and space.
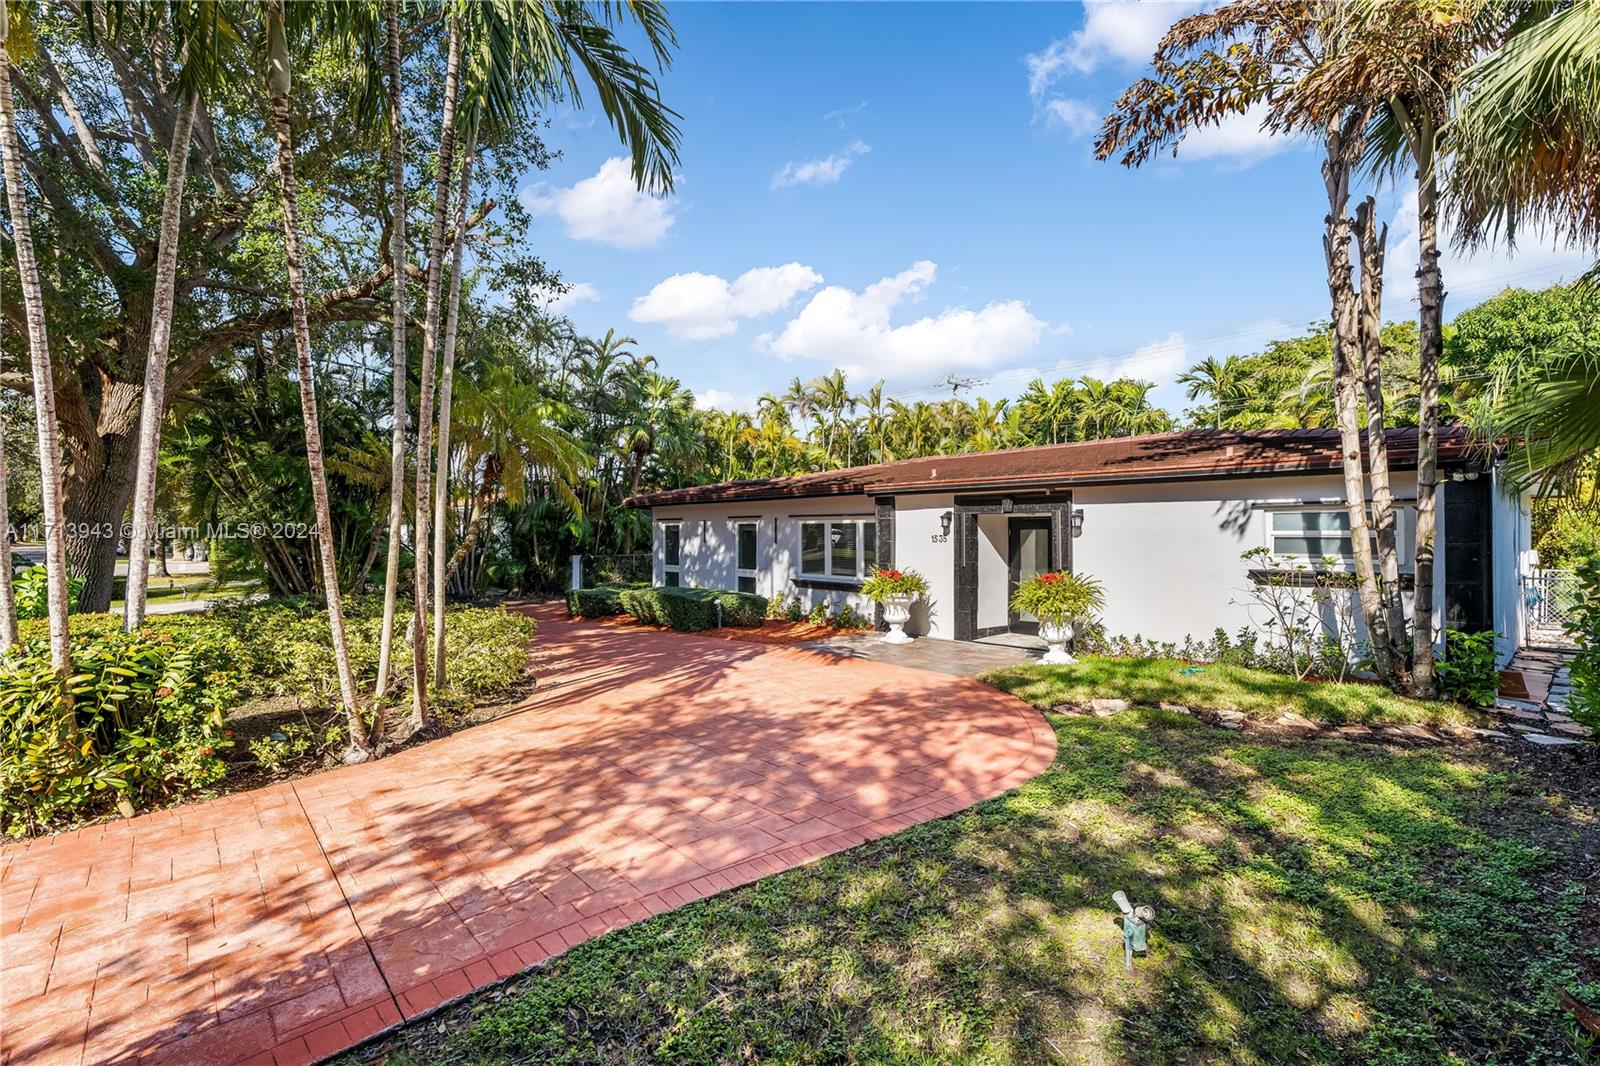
264, 0, 373, 762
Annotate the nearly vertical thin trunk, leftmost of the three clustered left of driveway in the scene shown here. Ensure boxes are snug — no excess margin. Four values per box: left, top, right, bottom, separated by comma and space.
376, 0, 411, 699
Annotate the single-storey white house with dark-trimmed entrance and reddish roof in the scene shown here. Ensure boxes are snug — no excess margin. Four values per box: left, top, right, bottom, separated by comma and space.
627, 429, 1530, 659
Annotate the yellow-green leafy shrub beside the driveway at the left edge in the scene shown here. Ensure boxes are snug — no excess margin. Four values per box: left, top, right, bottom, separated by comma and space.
0, 626, 238, 836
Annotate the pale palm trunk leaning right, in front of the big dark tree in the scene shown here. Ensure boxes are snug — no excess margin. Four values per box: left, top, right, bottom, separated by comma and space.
123, 94, 200, 632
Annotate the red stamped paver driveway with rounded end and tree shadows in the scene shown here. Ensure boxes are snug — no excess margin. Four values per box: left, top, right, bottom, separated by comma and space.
0, 608, 1056, 1064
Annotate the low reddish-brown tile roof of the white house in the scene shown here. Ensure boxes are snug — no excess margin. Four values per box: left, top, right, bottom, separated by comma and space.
624, 426, 1486, 507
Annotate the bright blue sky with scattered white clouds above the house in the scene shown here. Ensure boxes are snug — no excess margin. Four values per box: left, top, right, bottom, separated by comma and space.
522, 2, 1594, 415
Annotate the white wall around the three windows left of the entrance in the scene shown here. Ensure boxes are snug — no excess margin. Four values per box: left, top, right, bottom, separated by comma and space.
651, 496, 875, 615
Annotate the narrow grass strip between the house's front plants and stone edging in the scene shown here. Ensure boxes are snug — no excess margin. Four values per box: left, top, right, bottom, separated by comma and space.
982, 656, 1478, 725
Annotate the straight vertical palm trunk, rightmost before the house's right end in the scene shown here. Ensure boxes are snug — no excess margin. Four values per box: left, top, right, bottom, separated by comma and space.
1411, 139, 1445, 699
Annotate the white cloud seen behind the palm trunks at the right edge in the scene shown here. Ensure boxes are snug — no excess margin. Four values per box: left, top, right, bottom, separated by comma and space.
1384, 186, 1595, 305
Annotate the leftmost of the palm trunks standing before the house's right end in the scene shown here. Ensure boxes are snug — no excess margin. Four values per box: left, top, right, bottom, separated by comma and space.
1322, 115, 1392, 680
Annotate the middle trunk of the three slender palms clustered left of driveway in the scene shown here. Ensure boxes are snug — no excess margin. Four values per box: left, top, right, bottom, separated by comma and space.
411, 21, 461, 731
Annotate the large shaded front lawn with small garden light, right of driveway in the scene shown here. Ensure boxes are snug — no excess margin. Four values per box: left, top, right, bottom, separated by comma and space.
377, 709, 1600, 1064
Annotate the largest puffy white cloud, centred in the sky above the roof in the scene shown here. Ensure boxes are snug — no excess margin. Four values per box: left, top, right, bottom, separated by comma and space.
765, 259, 1048, 379
